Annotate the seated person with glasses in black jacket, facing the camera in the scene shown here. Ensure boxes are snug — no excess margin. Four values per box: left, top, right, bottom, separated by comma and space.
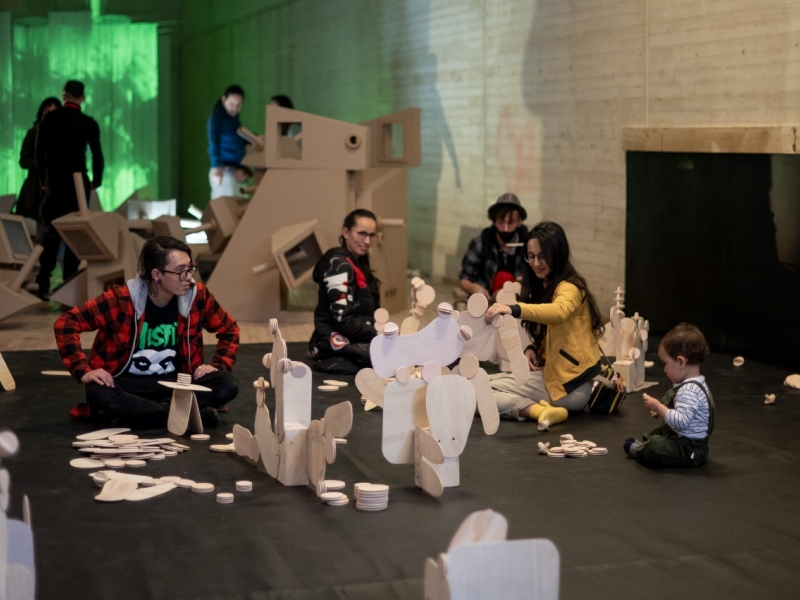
309, 209, 380, 374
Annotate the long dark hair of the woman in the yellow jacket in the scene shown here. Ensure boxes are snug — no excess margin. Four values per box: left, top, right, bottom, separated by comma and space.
521, 221, 603, 355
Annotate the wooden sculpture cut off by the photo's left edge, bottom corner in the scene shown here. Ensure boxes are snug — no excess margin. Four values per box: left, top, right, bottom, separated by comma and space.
0, 430, 36, 600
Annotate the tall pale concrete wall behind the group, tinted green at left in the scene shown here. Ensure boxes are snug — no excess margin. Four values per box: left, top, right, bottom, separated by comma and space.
170, 0, 800, 305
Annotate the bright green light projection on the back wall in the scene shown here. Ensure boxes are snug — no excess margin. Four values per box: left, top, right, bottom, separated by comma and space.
0, 11, 158, 210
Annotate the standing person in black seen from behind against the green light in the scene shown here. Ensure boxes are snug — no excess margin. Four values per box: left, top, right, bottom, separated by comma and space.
36, 80, 103, 299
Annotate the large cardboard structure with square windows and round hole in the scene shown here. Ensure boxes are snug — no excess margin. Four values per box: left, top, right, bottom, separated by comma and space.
208, 105, 420, 322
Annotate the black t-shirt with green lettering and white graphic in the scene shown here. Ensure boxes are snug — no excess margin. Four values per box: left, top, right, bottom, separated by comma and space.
128, 296, 178, 376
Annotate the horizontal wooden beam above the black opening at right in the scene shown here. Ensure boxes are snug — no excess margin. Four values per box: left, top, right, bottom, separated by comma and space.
622, 125, 800, 154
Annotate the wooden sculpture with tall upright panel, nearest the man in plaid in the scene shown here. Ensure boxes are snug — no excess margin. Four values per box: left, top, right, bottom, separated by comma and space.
233, 319, 353, 495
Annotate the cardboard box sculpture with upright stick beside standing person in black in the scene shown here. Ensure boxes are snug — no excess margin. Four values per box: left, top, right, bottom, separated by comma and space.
50, 173, 141, 306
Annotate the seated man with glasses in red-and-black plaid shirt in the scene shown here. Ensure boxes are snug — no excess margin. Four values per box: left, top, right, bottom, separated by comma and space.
54, 237, 239, 427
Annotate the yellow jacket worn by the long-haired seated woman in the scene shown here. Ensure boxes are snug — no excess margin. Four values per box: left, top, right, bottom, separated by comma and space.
519, 281, 600, 401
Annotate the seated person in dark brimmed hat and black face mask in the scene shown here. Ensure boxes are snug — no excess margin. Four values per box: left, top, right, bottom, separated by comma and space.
458, 192, 528, 298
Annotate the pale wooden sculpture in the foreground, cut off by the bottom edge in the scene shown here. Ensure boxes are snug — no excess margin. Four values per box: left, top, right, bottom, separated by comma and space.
425, 509, 561, 600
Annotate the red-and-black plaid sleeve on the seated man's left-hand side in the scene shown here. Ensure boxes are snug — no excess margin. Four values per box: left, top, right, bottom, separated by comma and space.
53, 288, 119, 382
